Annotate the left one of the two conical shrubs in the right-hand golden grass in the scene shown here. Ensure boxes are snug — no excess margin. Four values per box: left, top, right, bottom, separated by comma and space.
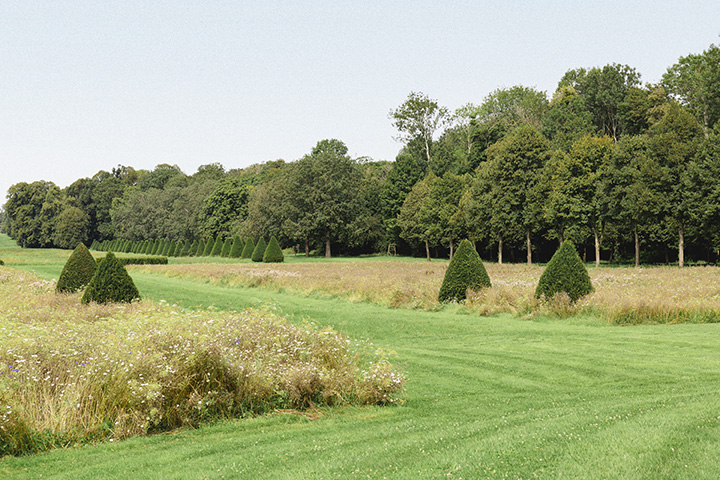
438, 240, 491, 302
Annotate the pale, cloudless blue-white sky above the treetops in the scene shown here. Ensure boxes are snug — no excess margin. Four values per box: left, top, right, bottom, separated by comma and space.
0, 0, 720, 204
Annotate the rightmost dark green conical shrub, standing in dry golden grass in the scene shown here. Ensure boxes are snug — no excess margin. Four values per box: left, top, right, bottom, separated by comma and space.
535, 241, 593, 303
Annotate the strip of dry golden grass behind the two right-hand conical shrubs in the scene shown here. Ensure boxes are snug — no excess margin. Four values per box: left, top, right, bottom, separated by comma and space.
131, 260, 720, 324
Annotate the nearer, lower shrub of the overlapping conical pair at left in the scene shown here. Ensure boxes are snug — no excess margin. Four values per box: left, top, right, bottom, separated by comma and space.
81, 252, 140, 303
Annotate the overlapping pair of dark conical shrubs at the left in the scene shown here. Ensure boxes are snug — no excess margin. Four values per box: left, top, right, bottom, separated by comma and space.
55, 243, 140, 303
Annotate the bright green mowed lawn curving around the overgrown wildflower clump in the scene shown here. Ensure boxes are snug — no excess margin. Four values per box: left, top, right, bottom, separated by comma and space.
0, 238, 720, 479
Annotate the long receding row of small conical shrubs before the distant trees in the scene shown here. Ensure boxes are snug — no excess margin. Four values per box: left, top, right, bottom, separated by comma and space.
90, 235, 285, 263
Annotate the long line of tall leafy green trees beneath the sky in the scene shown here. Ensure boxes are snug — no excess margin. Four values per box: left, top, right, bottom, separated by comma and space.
3, 45, 720, 265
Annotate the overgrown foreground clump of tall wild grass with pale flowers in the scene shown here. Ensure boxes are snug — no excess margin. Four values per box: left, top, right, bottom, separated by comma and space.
0, 270, 405, 456
